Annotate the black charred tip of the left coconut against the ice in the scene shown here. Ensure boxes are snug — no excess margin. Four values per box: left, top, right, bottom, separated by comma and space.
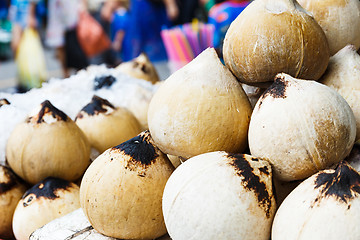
27, 100, 68, 124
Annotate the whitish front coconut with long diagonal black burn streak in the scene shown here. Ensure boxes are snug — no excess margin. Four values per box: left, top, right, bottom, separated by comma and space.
163, 151, 276, 240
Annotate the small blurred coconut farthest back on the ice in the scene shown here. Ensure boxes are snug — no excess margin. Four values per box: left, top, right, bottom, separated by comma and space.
116, 53, 160, 84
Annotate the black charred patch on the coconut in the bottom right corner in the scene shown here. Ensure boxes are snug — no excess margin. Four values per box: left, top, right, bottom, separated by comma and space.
311, 161, 360, 207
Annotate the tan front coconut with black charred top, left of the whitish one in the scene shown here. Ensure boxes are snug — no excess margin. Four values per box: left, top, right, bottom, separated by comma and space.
80, 131, 174, 239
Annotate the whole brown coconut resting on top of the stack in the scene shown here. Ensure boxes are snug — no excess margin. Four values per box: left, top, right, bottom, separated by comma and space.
223, 0, 330, 85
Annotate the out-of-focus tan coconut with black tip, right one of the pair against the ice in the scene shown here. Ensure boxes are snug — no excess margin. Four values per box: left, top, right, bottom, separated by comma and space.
75, 96, 141, 153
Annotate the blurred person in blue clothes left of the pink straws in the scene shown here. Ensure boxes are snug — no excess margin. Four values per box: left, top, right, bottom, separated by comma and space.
111, 0, 179, 62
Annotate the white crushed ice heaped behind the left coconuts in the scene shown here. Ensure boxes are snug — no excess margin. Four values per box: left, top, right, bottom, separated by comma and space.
0, 65, 157, 164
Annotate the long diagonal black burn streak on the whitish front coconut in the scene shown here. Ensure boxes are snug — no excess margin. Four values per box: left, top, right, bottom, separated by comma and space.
228, 154, 271, 217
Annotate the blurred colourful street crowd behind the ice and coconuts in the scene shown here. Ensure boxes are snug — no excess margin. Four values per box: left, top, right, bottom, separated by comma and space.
0, 0, 250, 93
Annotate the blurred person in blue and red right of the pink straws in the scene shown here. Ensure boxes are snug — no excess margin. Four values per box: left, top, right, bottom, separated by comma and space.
208, 0, 251, 58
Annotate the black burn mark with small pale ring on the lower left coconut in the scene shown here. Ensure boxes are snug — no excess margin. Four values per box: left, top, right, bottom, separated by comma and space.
22, 177, 72, 207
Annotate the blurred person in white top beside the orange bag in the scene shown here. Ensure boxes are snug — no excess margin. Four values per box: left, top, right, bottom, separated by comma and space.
45, 0, 88, 78
